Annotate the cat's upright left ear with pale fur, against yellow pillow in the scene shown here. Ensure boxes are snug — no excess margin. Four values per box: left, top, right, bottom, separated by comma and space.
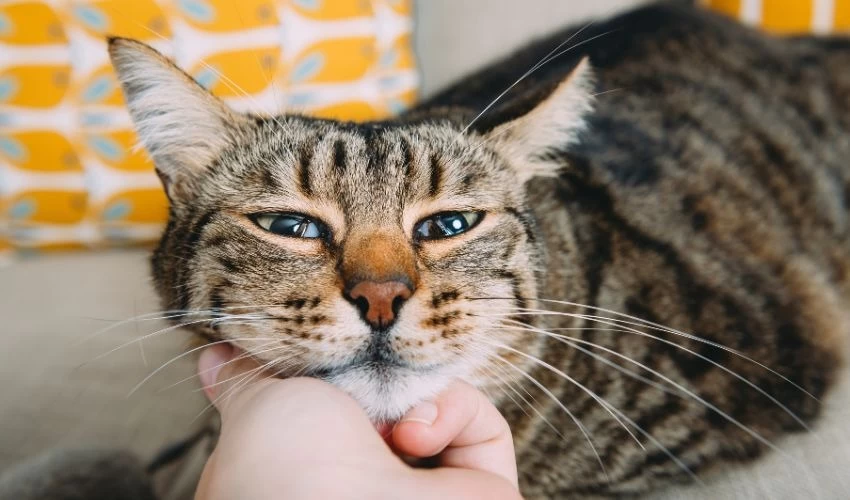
109, 38, 245, 197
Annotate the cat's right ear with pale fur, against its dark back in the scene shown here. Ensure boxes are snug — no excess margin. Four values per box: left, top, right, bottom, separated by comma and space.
487, 57, 594, 182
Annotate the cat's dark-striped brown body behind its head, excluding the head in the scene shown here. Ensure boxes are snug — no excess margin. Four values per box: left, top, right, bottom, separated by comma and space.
423, 6, 850, 498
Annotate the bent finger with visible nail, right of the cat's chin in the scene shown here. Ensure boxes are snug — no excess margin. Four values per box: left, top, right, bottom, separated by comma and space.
392, 382, 517, 487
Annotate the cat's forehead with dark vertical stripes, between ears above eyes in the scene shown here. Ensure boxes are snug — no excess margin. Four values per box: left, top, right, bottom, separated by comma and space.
233, 118, 510, 224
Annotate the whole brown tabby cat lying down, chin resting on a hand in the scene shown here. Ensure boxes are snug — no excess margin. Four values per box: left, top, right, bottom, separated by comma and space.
110, 3, 850, 498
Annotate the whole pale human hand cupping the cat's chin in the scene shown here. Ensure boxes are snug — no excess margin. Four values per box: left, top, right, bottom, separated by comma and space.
195, 344, 522, 500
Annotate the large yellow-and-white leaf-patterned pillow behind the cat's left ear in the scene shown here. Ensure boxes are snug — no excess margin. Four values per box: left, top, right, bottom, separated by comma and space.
0, 0, 418, 251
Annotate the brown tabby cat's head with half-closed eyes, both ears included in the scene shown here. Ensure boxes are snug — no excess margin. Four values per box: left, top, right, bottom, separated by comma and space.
110, 39, 591, 420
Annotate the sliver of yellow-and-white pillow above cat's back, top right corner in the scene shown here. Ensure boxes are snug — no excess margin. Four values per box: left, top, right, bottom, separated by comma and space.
703, 0, 850, 34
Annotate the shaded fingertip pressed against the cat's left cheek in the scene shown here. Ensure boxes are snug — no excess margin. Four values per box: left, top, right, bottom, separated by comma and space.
198, 343, 266, 412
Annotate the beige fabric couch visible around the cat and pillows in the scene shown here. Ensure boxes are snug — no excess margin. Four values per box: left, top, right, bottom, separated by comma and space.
0, 0, 850, 499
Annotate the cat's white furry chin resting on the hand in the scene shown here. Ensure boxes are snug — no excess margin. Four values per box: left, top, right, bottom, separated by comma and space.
323, 365, 452, 425
